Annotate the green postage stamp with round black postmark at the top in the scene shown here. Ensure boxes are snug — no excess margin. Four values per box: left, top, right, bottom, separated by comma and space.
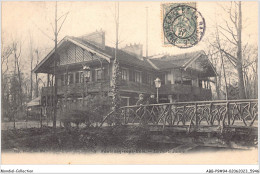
161, 3, 206, 48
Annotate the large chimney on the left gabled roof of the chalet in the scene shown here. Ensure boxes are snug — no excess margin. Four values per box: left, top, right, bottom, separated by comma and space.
80, 29, 106, 50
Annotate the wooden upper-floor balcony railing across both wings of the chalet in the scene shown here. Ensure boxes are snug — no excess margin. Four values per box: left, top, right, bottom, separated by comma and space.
42, 80, 212, 100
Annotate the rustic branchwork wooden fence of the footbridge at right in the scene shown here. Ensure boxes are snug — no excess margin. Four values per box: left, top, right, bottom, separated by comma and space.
101, 99, 258, 130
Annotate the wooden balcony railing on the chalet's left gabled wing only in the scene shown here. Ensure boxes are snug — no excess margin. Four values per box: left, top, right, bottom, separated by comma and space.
42, 81, 110, 96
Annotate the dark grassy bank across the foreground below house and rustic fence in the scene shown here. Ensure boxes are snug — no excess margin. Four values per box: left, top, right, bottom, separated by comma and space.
2, 123, 255, 153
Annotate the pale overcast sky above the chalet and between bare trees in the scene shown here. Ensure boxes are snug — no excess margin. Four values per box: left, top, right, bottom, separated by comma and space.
2, 2, 258, 75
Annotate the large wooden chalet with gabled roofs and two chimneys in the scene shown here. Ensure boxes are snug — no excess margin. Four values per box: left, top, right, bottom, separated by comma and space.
34, 31, 216, 109
